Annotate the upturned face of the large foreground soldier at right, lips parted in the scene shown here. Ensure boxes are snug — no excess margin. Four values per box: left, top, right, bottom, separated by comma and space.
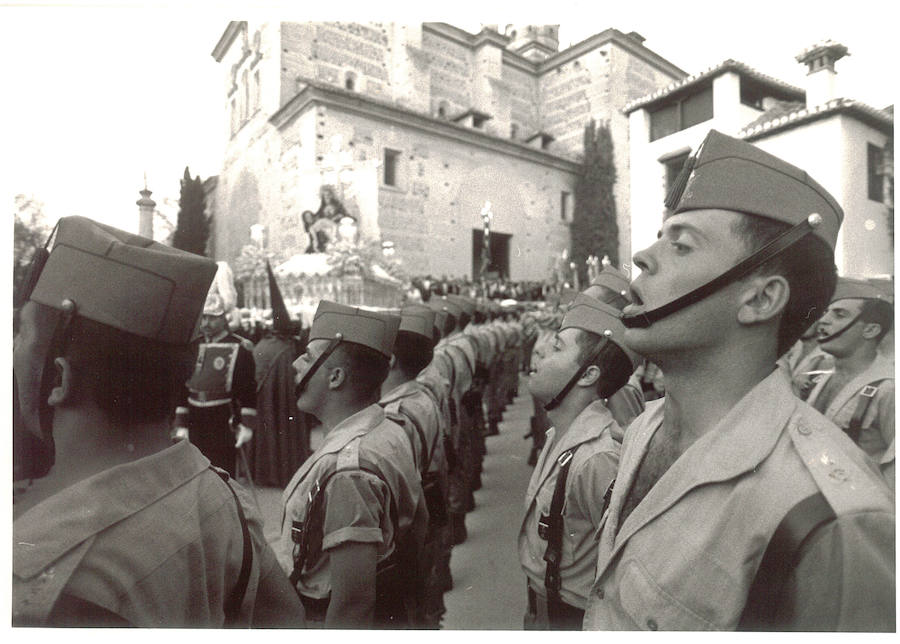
623, 209, 750, 357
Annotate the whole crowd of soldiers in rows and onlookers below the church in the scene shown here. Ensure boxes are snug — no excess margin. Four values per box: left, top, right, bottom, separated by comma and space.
12, 131, 896, 632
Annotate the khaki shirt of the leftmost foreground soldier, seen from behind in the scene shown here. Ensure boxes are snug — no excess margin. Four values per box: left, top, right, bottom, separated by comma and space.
13, 441, 303, 627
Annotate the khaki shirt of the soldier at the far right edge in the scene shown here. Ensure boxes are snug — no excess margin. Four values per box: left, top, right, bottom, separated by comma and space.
806, 354, 895, 488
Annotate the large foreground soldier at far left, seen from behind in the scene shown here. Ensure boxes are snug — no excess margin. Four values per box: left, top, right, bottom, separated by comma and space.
12, 217, 304, 627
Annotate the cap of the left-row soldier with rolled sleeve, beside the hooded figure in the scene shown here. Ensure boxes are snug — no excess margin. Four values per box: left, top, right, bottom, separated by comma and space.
309, 300, 400, 359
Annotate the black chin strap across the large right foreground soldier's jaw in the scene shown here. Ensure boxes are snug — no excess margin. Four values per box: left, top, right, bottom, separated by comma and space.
622, 213, 822, 329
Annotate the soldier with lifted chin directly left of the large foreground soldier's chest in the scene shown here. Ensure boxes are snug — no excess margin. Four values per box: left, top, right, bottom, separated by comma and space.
519, 280, 637, 630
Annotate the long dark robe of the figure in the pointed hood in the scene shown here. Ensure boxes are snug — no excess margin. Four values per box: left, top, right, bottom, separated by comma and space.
248, 334, 315, 488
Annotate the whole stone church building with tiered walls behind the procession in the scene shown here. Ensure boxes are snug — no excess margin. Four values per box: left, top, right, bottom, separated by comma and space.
208, 22, 685, 280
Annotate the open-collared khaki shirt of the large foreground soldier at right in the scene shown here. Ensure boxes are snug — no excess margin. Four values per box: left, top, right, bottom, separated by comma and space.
584, 370, 895, 630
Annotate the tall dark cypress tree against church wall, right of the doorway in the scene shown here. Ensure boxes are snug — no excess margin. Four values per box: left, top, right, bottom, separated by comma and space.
569, 119, 619, 284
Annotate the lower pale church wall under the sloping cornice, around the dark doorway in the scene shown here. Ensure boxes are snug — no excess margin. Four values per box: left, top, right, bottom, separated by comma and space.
272, 106, 574, 279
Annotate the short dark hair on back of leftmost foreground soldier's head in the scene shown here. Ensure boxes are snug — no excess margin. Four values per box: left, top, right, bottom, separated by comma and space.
63, 316, 193, 425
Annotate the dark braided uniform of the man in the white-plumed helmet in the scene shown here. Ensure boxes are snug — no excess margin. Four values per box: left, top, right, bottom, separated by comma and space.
176, 331, 256, 476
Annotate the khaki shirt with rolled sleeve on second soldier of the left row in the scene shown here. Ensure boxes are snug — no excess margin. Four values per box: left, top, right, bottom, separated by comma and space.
278, 404, 428, 599
